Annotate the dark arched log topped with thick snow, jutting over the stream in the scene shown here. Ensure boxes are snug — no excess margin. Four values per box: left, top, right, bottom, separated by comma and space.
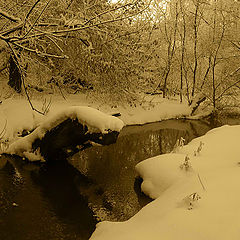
6, 106, 124, 161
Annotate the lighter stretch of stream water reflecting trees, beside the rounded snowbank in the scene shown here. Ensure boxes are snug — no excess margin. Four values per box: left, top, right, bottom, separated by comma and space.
69, 121, 213, 221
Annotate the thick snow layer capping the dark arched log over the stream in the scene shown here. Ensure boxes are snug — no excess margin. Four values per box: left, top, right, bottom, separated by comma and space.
6, 106, 124, 161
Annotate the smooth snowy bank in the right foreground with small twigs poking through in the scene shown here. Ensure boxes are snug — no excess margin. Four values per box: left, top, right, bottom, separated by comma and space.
91, 126, 240, 240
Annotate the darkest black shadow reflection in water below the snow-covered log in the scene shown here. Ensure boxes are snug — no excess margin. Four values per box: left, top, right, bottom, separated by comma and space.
31, 161, 97, 239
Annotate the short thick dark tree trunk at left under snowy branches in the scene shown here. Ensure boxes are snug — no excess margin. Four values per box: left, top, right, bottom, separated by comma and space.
8, 56, 22, 93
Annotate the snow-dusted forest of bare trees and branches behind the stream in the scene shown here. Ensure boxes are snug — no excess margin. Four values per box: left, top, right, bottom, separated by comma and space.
0, 0, 240, 112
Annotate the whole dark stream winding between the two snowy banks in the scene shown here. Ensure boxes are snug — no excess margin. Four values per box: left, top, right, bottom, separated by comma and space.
0, 120, 240, 240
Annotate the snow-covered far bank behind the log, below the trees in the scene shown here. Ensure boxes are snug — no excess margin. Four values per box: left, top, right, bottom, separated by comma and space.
0, 95, 191, 142
